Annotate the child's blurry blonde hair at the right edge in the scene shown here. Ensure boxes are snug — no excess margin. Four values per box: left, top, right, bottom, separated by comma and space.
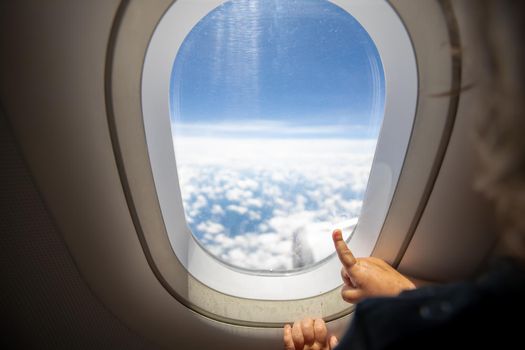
475, 0, 525, 260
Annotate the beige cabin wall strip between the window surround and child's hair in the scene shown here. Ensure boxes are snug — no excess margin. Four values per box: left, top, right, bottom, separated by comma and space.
399, 0, 496, 281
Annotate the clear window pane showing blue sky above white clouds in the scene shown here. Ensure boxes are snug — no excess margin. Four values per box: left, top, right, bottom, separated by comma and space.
170, 0, 385, 272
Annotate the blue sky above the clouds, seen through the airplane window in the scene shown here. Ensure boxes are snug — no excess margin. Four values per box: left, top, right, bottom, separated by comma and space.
171, 0, 385, 138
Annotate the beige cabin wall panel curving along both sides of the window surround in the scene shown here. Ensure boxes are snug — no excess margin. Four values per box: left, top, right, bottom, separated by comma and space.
0, 0, 495, 350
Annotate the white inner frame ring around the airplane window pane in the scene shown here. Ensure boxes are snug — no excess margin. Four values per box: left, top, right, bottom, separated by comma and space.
141, 0, 418, 300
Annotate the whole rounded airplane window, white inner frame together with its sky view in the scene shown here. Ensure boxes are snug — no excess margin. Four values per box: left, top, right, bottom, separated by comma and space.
141, 0, 418, 300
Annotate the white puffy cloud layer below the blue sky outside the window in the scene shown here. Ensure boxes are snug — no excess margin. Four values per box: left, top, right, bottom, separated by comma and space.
175, 137, 375, 271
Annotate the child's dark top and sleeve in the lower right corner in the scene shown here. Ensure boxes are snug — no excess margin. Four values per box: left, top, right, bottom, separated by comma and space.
337, 258, 525, 350
